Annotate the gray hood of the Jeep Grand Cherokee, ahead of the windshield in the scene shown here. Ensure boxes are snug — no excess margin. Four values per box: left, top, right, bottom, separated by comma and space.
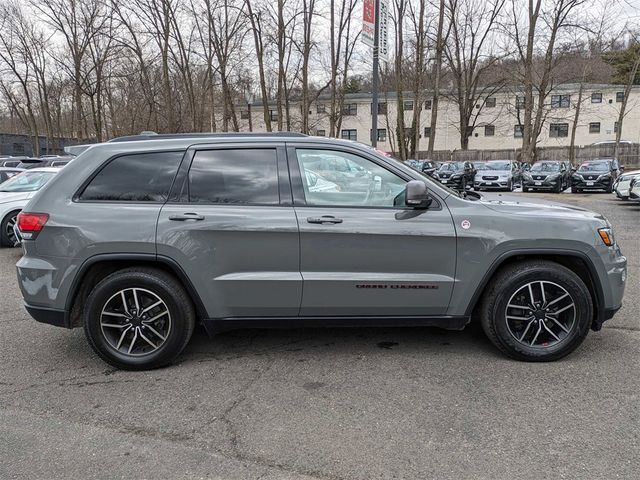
480, 195, 607, 223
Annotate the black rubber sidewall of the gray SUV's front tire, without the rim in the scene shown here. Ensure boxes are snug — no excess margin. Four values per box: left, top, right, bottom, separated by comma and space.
492, 267, 593, 360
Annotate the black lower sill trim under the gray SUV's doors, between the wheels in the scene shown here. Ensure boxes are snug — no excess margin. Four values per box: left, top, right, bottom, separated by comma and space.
202, 316, 470, 335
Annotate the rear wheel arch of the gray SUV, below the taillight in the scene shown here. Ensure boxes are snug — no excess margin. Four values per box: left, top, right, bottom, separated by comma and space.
65, 254, 207, 328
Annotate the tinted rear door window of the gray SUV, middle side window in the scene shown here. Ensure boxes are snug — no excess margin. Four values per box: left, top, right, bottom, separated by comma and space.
189, 148, 280, 205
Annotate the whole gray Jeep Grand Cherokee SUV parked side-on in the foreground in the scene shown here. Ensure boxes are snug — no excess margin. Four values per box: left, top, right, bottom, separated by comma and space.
17, 134, 627, 370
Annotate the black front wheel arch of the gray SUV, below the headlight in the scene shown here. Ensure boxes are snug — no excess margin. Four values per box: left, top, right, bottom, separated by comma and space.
466, 250, 604, 330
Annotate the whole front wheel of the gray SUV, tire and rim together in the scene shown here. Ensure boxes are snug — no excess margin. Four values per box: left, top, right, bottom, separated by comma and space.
480, 260, 593, 362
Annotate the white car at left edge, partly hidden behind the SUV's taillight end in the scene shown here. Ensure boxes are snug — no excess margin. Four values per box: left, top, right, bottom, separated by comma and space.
0, 167, 60, 247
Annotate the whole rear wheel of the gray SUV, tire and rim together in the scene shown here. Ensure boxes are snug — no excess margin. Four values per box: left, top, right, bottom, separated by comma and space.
84, 267, 195, 370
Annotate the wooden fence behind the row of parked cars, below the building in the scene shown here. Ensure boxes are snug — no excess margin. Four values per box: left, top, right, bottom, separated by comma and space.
418, 144, 640, 168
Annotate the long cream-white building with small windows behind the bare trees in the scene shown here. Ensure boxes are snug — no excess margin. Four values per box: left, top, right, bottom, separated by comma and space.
239, 84, 640, 151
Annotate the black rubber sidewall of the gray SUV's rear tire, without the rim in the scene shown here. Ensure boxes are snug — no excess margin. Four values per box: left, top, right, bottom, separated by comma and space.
84, 272, 190, 369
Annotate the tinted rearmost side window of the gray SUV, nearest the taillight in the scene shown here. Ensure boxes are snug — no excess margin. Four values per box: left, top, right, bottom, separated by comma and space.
80, 152, 184, 202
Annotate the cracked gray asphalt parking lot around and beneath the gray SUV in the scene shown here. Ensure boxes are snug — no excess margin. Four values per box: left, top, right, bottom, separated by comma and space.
0, 193, 640, 479
